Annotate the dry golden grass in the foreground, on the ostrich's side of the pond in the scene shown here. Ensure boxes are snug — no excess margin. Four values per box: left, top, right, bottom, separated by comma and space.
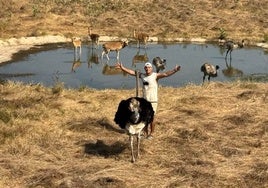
0, 82, 268, 187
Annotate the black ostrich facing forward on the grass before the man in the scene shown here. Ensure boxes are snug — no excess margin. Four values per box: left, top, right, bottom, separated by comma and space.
114, 97, 154, 162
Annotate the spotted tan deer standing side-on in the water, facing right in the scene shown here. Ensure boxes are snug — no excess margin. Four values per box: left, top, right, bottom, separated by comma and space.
101, 41, 128, 60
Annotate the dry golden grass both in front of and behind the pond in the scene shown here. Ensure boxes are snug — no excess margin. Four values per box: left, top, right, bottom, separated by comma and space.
0, 0, 268, 188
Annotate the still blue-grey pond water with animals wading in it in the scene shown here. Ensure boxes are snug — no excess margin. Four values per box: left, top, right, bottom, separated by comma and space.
0, 42, 268, 89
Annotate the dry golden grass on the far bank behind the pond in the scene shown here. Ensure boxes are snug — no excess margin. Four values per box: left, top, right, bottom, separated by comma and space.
0, 0, 268, 42
